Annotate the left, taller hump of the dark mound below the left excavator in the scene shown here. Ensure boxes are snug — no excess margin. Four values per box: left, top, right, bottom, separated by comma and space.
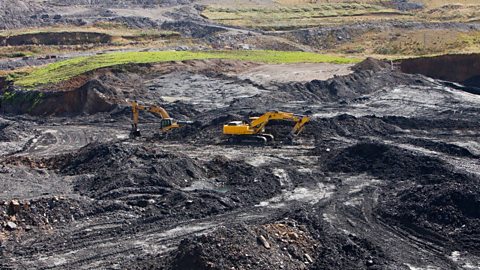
61, 143, 206, 197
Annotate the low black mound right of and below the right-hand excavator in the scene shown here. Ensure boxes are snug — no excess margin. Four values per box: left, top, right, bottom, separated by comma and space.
325, 142, 468, 183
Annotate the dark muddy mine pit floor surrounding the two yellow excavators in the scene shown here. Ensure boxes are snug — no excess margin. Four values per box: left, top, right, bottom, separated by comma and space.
0, 60, 480, 269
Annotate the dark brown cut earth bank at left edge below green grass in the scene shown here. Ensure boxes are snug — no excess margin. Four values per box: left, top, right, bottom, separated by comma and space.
0, 80, 116, 116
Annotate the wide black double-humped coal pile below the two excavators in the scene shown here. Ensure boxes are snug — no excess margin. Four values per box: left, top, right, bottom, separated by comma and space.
54, 142, 281, 220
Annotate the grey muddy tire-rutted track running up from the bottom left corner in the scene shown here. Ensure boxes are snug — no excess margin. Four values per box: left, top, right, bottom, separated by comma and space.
12, 207, 283, 269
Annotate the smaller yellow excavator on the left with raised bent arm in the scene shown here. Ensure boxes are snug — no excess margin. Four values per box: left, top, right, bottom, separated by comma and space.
130, 101, 193, 137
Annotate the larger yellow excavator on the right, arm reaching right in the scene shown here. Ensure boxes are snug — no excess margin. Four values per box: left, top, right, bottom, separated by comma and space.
223, 111, 310, 144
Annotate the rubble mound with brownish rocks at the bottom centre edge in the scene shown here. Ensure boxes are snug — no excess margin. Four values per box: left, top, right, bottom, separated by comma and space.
170, 223, 316, 269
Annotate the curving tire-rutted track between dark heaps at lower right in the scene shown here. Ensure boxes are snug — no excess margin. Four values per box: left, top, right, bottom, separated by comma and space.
323, 175, 458, 270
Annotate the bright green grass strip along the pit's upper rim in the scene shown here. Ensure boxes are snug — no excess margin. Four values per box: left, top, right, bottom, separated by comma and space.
15, 51, 361, 88
